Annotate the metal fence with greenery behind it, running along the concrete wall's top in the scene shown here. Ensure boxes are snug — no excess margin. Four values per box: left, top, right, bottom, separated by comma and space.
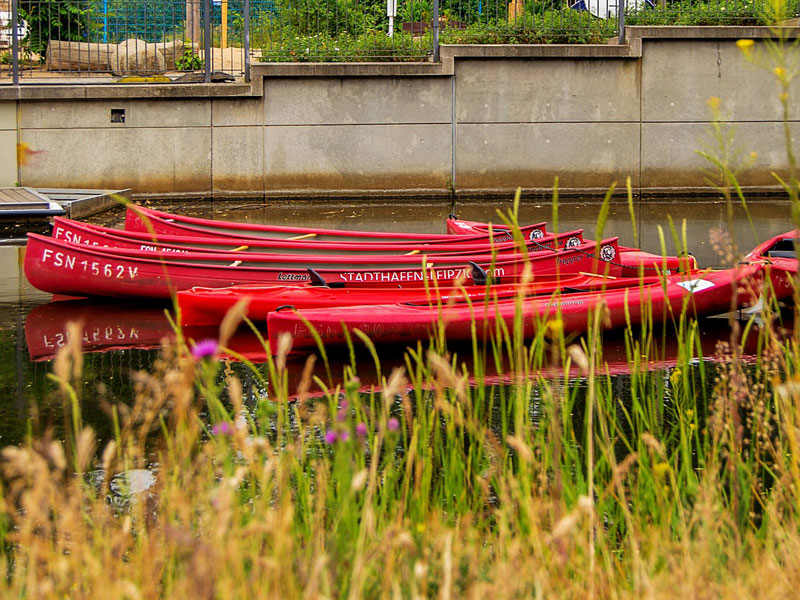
0, 0, 800, 84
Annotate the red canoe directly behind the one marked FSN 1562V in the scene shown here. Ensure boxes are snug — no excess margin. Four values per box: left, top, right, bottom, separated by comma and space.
52, 217, 583, 255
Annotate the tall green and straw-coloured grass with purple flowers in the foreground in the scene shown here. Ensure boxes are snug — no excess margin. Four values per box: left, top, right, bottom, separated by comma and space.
0, 202, 800, 598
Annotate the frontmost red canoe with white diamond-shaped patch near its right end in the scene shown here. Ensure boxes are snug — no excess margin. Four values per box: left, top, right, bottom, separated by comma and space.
267, 264, 776, 350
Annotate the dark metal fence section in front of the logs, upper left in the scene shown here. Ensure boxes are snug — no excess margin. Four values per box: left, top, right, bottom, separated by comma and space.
0, 0, 252, 84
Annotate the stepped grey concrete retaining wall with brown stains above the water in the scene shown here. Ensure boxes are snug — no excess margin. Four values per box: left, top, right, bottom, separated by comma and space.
0, 28, 798, 197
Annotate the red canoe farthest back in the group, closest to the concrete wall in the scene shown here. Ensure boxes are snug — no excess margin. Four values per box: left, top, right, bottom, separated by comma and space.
125, 205, 545, 243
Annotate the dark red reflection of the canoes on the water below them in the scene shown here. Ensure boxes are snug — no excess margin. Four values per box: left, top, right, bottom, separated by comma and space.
25, 300, 793, 398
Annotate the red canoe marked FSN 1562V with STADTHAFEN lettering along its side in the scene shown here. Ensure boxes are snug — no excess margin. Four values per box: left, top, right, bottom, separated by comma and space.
24, 233, 623, 298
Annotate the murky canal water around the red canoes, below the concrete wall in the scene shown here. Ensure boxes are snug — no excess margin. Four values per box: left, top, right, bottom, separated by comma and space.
0, 199, 792, 446
